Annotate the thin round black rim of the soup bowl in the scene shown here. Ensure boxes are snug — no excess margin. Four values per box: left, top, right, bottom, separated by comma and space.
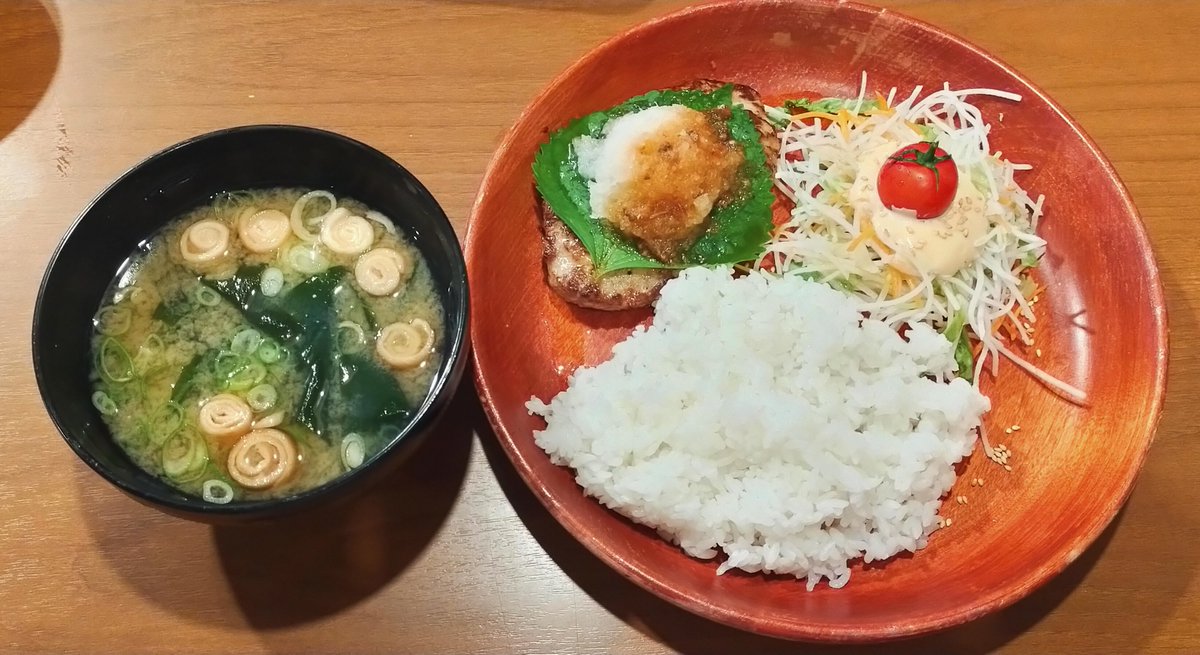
31, 124, 470, 519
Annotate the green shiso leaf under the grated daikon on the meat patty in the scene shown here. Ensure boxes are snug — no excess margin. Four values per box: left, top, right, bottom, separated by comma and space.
533, 85, 774, 275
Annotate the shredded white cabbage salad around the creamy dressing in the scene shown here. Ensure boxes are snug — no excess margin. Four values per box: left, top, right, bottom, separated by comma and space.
756, 78, 1045, 385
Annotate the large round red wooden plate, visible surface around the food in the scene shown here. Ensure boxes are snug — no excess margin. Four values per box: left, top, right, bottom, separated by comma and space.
467, 1, 1168, 642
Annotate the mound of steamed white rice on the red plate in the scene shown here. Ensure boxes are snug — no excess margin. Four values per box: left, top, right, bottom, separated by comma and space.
527, 268, 989, 590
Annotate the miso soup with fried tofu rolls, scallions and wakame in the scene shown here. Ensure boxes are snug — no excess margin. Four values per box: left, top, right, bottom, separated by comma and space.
92, 190, 444, 503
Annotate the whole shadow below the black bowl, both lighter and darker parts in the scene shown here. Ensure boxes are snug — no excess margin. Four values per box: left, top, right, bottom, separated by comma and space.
80, 384, 475, 631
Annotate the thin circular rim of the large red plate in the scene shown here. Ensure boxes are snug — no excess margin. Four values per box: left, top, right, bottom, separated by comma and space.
466, 0, 1170, 643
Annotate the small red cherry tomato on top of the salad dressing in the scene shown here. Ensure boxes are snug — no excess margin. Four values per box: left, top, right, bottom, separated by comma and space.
878, 142, 959, 218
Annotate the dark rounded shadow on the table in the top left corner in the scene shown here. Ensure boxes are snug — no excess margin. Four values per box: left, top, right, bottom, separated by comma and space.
0, 0, 61, 139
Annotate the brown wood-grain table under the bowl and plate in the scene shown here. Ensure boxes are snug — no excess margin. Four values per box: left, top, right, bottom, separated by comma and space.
0, 0, 1200, 654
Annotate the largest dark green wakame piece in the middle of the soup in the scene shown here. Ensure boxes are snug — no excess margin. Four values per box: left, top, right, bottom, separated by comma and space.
204, 266, 410, 439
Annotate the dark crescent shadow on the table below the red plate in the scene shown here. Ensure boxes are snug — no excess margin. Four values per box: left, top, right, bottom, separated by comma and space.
476, 412, 1121, 655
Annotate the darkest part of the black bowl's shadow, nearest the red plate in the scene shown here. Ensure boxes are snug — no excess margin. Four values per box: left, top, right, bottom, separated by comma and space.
212, 384, 474, 629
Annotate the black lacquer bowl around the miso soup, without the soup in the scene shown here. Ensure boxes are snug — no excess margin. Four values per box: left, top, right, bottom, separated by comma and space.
32, 125, 468, 523
